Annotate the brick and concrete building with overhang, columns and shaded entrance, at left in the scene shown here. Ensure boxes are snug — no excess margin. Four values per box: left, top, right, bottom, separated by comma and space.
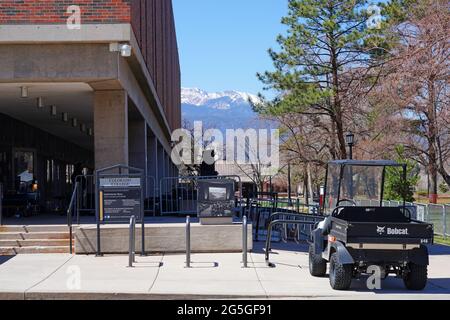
0, 0, 181, 216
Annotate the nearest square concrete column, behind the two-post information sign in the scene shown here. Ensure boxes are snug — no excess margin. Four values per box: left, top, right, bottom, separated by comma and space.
94, 90, 129, 169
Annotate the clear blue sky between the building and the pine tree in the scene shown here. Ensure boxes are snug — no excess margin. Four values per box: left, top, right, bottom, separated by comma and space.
173, 0, 287, 93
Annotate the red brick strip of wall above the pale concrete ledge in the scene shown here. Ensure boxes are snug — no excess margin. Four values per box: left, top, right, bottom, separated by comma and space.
0, 0, 131, 24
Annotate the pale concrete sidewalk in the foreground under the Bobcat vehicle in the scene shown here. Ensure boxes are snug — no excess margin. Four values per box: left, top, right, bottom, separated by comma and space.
0, 244, 450, 299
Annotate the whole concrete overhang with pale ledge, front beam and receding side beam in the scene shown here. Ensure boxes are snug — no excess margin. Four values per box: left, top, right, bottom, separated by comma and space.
0, 24, 171, 152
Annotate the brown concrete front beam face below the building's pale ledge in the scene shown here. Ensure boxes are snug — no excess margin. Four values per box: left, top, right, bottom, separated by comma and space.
0, 43, 118, 83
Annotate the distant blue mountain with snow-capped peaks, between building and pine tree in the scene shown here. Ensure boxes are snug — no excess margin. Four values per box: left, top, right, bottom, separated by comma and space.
181, 88, 266, 130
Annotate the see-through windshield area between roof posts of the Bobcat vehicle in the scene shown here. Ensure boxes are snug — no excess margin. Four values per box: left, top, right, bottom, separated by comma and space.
325, 164, 384, 213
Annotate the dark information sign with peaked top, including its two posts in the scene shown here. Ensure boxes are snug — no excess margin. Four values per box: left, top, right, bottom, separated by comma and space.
95, 165, 145, 256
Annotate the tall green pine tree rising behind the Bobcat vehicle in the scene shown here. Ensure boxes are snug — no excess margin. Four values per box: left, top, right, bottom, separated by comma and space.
255, 0, 394, 159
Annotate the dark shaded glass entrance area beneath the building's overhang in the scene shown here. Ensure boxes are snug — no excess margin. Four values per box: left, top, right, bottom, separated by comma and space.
0, 113, 93, 221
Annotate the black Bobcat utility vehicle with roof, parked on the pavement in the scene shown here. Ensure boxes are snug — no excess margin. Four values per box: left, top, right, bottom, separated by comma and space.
309, 160, 434, 290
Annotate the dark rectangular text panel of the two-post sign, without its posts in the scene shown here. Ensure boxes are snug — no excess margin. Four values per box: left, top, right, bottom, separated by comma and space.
99, 175, 143, 223
